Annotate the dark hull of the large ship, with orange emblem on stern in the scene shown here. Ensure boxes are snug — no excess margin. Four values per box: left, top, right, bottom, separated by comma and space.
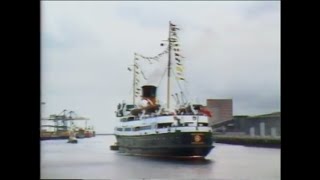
116, 132, 214, 158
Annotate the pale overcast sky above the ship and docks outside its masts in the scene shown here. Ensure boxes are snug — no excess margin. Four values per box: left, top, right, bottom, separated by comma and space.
41, 1, 280, 132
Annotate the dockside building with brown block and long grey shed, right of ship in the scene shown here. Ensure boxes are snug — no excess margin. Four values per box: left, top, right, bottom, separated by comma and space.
207, 99, 281, 137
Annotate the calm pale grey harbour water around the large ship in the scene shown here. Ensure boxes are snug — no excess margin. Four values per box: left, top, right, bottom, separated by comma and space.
41, 136, 280, 180
